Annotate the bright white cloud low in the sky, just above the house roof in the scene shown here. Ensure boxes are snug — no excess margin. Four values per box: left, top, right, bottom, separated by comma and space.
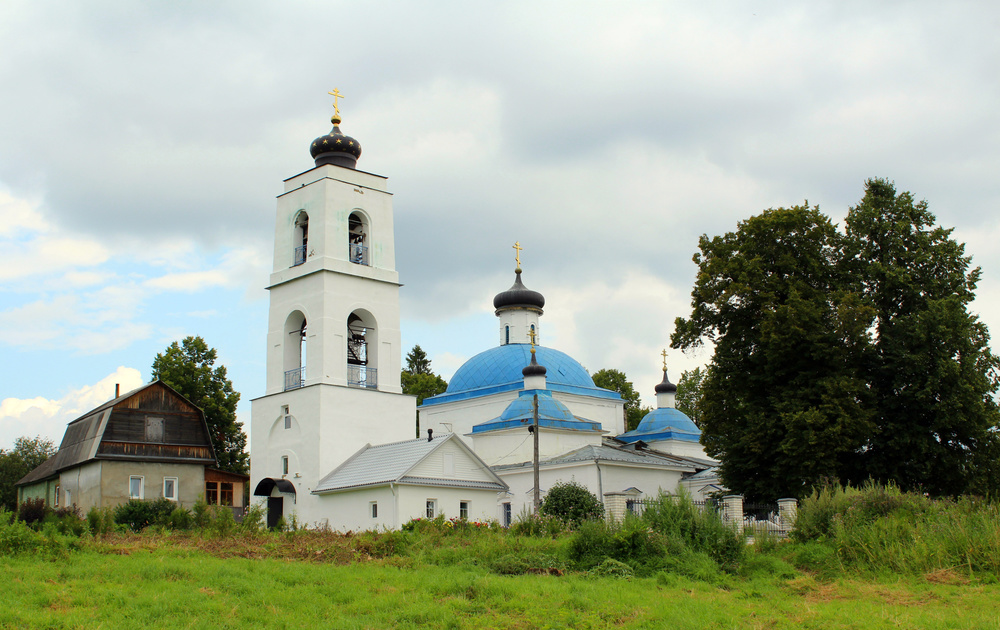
0, 366, 143, 448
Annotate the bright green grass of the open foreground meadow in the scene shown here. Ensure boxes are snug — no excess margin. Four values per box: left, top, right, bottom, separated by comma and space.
0, 534, 1000, 629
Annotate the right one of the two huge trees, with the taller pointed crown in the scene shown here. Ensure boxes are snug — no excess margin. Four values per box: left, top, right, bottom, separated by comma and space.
844, 179, 1000, 494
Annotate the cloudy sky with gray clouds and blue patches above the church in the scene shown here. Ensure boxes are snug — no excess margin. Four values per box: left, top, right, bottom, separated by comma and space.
0, 0, 1000, 448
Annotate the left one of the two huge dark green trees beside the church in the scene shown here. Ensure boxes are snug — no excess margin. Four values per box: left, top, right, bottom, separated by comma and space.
671, 205, 872, 499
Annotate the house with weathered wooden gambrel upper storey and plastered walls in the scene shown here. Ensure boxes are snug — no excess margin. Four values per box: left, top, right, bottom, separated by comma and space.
17, 381, 215, 513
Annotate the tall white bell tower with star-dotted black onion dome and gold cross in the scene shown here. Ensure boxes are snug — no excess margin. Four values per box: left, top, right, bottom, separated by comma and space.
250, 90, 416, 526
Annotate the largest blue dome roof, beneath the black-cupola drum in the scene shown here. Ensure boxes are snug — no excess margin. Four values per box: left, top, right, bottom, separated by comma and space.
422, 343, 621, 407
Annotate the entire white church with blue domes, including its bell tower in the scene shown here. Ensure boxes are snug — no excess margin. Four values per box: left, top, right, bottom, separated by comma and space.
250, 97, 716, 530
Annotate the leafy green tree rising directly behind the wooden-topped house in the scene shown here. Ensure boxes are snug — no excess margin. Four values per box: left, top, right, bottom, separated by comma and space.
152, 337, 250, 474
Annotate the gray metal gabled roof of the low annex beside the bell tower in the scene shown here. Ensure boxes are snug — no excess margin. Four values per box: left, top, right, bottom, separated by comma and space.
313, 434, 507, 494
